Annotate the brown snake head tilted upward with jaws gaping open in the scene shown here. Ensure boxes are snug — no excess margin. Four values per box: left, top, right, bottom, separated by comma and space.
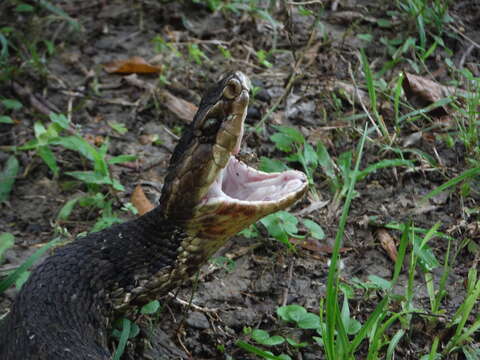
160, 71, 308, 238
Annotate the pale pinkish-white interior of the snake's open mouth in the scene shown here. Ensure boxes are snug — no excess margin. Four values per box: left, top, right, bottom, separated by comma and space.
205, 156, 307, 204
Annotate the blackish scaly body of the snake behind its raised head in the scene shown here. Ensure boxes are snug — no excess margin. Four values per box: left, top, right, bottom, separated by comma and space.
0, 209, 188, 360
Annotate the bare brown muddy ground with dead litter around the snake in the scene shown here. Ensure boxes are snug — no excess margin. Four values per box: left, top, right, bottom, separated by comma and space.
0, 0, 480, 360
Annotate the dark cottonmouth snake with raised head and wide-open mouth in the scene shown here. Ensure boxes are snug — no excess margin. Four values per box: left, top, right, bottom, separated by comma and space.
0, 72, 307, 360
